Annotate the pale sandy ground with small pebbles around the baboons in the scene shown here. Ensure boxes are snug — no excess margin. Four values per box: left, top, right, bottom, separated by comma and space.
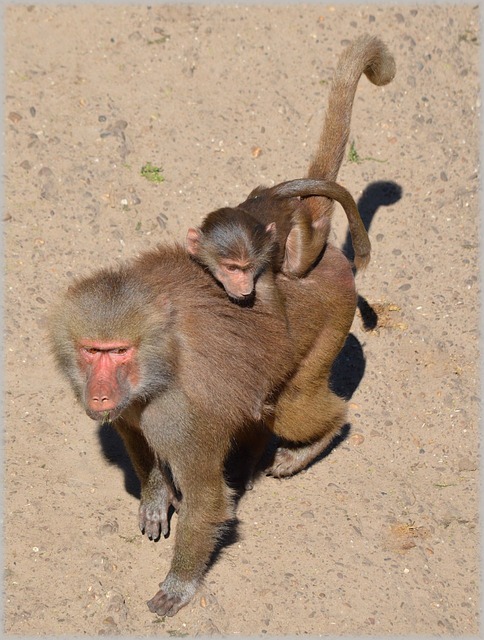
4, 4, 480, 636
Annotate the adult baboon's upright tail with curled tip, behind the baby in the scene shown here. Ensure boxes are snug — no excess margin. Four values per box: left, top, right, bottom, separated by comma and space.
308, 34, 396, 180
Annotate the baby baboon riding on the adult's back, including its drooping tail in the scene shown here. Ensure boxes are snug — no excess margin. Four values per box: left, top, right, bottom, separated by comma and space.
186, 179, 371, 300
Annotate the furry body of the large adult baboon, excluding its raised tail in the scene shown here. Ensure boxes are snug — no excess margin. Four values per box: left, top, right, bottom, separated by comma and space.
50, 240, 356, 615
